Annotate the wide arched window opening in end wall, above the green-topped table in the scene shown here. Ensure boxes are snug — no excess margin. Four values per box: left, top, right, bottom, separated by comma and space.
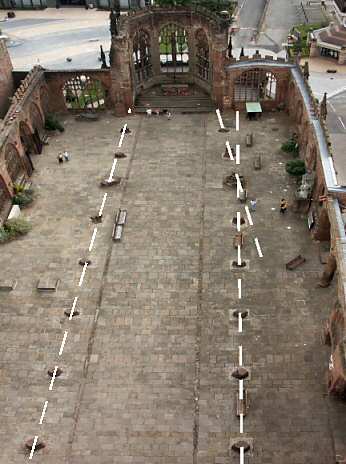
234, 68, 276, 102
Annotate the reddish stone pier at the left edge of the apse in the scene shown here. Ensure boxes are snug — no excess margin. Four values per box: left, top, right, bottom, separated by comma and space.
111, 34, 134, 116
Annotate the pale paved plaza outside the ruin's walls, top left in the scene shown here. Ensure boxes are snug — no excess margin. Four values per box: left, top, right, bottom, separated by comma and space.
0, 8, 110, 71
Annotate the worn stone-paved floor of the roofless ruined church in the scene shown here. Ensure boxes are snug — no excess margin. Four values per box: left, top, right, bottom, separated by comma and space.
0, 113, 335, 464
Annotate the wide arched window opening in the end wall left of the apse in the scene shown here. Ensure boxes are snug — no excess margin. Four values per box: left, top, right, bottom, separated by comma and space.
63, 75, 105, 110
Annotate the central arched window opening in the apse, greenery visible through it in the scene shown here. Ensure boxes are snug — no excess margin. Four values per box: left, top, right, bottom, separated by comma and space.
159, 24, 189, 74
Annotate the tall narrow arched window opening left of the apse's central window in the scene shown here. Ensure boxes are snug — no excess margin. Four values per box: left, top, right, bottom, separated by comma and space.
133, 31, 152, 83
